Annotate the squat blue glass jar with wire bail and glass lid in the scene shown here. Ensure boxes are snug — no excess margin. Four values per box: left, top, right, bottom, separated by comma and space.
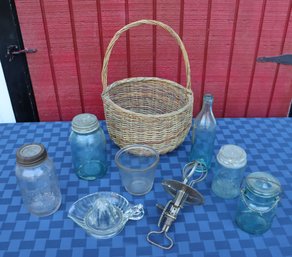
235, 172, 282, 234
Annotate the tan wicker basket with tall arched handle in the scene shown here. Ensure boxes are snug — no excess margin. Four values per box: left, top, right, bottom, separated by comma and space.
101, 20, 194, 154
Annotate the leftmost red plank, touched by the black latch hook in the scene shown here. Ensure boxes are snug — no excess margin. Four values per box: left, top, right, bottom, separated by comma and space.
15, 0, 61, 121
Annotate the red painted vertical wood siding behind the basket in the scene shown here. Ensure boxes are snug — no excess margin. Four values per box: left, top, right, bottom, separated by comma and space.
15, 0, 292, 121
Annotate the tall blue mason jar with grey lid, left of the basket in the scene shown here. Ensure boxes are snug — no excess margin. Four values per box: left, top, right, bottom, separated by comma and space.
69, 113, 107, 180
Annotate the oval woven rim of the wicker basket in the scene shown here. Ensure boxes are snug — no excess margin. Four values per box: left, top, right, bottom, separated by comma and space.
101, 77, 194, 118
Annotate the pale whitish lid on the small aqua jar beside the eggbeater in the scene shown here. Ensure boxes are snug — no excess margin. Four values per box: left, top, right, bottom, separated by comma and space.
217, 145, 247, 169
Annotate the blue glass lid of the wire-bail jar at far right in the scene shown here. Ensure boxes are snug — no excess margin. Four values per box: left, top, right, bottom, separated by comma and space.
246, 171, 281, 198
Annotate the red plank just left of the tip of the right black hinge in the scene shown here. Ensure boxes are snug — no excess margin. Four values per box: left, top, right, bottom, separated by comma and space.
225, 0, 263, 117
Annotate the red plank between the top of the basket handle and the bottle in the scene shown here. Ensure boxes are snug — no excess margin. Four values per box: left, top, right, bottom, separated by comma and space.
181, 0, 208, 115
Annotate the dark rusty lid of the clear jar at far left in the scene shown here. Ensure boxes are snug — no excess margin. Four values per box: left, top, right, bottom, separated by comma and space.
16, 143, 48, 166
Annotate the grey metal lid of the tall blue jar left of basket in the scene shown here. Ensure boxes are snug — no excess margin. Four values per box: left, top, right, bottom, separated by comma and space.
72, 113, 99, 134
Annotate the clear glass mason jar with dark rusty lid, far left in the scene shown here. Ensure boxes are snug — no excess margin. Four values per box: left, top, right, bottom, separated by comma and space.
15, 143, 62, 216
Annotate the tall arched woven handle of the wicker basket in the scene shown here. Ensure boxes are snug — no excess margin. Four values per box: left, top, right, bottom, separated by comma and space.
101, 20, 191, 90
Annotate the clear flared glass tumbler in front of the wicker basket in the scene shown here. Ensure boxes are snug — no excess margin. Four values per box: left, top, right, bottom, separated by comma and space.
115, 145, 159, 195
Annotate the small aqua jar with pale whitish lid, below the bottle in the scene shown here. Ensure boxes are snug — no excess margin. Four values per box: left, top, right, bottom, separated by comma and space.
212, 145, 247, 199
